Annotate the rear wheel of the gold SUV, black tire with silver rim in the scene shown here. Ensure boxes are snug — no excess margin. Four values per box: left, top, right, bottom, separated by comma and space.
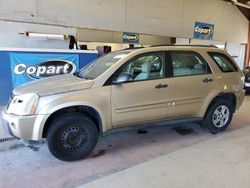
202, 98, 233, 134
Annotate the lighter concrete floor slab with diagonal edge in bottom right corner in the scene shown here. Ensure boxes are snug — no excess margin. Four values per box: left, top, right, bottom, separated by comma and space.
80, 123, 250, 188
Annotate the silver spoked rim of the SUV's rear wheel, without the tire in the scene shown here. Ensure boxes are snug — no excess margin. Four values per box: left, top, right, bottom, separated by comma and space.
212, 105, 230, 128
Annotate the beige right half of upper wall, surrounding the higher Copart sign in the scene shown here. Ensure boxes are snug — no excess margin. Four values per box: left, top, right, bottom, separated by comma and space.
127, 0, 248, 42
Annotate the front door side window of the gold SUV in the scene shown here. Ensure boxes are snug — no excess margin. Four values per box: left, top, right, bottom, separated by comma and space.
122, 52, 165, 81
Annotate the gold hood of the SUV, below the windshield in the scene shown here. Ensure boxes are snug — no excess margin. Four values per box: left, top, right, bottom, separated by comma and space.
13, 74, 93, 96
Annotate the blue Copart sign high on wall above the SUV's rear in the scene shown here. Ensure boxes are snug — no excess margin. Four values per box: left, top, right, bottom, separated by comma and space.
194, 22, 214, 40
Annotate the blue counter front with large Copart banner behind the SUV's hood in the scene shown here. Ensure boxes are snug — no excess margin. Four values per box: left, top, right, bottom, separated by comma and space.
0, 49, 97, 106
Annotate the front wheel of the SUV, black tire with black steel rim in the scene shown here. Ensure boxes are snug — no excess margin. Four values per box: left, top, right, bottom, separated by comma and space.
47, 112, 98, 161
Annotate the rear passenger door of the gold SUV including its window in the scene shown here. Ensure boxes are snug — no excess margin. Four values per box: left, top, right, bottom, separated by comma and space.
168, 51, 215, 118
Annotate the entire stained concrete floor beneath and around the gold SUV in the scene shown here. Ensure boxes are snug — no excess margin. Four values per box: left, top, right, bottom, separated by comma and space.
0, 96, 250, 188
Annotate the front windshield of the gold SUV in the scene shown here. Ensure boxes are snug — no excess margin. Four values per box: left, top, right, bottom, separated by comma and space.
76, 50, 131, 80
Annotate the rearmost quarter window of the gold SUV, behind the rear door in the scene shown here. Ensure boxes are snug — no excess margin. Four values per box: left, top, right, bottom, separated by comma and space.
208, 52, 238, 72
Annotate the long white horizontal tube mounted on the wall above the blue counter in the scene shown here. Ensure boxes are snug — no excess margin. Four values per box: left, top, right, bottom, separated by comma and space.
25, 32, 68, 40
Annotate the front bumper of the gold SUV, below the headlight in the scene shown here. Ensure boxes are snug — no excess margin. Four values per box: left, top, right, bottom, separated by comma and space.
2, 110, 42, 140
